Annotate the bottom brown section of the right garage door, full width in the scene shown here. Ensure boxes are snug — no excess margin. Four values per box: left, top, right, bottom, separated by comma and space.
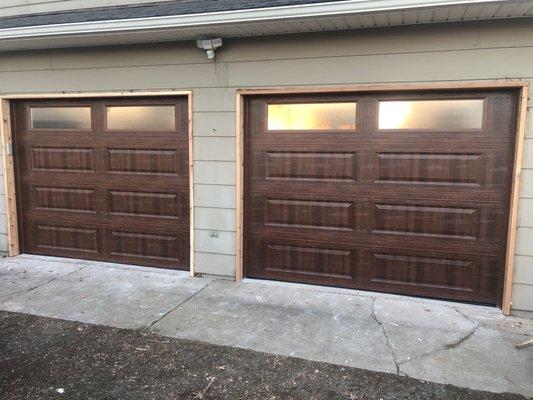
245, 238, 501, 301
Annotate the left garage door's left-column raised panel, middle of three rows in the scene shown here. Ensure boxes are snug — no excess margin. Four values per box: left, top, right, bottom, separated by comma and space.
33, 186, 96, 212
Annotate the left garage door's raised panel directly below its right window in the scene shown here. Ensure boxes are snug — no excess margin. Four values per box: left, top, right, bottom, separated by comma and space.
107, 149, 187, 175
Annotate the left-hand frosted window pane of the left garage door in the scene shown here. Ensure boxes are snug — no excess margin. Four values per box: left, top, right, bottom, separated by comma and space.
31, 107, 91, 130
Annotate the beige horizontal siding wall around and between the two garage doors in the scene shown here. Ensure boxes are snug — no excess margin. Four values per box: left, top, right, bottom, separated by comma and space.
0, 20, 533, 315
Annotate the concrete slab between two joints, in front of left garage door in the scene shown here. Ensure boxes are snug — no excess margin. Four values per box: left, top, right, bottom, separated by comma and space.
2, 263, 209, 329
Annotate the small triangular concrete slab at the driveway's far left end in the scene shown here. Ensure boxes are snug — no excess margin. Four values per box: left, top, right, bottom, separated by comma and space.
0, 258, 83, 302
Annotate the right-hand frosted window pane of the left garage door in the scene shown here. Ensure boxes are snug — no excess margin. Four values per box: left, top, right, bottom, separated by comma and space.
107, 106, 176, 132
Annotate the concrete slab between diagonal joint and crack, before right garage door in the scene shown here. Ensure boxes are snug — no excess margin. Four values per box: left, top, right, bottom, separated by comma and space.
151, 281, 396, 372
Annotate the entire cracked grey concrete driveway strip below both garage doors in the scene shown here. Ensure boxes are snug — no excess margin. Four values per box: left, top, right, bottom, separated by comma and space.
0, 255, 533, 396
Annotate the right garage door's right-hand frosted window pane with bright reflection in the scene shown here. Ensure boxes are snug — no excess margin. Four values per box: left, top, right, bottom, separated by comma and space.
379, 99, 483, 131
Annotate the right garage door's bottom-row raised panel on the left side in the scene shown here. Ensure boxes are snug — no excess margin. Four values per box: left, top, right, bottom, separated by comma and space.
264, 243, 353, 279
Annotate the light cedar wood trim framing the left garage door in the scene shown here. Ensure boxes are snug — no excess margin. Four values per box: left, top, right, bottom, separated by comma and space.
0, 90, 195, 276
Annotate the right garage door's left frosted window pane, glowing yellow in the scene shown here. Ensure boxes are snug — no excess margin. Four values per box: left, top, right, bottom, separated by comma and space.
268, 103, 357, 131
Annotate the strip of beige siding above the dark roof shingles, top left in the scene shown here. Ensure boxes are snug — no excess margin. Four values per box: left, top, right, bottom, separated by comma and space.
0, 0, 168, 17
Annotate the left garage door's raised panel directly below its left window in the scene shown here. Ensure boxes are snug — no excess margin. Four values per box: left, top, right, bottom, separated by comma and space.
31, 147, 94, 172
